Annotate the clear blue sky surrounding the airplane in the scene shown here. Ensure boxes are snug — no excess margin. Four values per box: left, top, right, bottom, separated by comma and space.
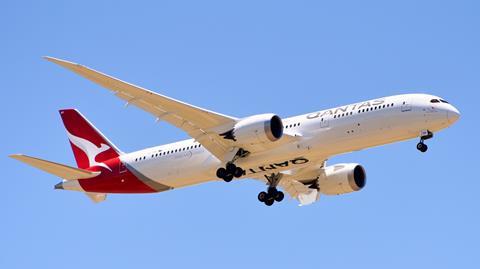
0, 0, 480, 269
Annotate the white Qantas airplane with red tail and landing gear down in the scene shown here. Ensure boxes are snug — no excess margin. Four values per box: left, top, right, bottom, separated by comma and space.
10, 57, 460, 203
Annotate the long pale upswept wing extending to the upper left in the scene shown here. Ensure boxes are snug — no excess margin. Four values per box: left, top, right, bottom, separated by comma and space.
45, 57, 238, 161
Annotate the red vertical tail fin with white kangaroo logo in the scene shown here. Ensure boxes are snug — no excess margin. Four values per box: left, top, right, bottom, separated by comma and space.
60, 109, 121, 171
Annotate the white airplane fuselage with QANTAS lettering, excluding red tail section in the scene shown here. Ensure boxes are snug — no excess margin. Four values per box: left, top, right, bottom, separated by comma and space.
121, 94, 459, 188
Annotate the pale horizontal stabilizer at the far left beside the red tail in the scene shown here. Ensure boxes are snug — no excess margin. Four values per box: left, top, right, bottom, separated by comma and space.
9, 154, 101, 180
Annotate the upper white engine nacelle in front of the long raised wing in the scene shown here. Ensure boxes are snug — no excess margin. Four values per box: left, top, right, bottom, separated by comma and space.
221, 114, 284, 145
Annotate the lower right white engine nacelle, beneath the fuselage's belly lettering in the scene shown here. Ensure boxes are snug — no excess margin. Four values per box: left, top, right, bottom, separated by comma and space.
318, 163, 367, 195
